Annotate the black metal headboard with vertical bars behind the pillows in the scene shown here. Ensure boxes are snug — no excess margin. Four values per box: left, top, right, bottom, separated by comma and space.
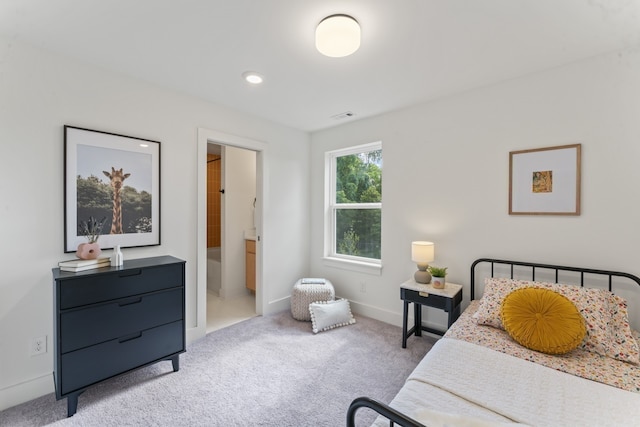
471, 258, 640, 300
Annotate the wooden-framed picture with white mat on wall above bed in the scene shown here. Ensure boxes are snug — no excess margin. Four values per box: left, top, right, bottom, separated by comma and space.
509, 144, 582, 215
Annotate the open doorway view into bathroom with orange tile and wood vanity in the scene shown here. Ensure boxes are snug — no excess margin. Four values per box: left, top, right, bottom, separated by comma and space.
206, 142, 257, 333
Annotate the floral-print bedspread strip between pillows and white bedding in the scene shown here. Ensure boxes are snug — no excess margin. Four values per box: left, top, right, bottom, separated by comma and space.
444, 301, 640, 393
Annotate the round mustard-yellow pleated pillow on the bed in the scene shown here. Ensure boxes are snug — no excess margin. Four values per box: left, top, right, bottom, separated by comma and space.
500, 288, 587, 354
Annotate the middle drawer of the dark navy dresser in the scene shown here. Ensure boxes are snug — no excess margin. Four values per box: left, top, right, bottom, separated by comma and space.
60, 288, 184, 353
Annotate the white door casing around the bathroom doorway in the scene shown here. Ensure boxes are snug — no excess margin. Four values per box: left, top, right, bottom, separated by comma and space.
194, 128, 268, 341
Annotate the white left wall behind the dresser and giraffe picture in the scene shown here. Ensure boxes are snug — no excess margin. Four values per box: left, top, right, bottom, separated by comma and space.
0, 38, 309, 410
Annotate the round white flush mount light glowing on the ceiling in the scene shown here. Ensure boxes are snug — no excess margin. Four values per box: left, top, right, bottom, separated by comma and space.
316, 15, 360, 58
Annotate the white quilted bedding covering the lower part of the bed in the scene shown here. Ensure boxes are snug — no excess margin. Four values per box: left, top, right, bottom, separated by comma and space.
375, 338, 640, 427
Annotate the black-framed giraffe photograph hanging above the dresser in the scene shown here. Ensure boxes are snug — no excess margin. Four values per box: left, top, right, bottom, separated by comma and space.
64, 125, 160, 252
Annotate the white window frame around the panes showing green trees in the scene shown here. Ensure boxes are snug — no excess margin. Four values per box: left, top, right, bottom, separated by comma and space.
323, 141, 384, 275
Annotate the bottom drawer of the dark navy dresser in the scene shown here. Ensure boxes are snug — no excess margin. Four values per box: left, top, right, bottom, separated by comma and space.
60, 321, 184, 395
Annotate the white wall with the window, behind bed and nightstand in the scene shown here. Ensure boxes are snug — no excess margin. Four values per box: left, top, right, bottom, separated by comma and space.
311, 48, 640, 329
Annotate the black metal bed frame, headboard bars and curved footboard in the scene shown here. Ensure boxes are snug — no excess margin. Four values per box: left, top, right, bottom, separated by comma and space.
347, 258, 640, 427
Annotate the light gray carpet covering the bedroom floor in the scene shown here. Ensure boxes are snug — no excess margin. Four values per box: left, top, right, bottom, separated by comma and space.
0, 312, 435, 427
